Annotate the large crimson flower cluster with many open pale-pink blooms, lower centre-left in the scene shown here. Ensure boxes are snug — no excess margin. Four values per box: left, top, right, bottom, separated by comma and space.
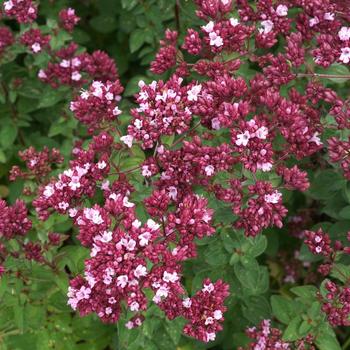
63, 171, 228, 342
